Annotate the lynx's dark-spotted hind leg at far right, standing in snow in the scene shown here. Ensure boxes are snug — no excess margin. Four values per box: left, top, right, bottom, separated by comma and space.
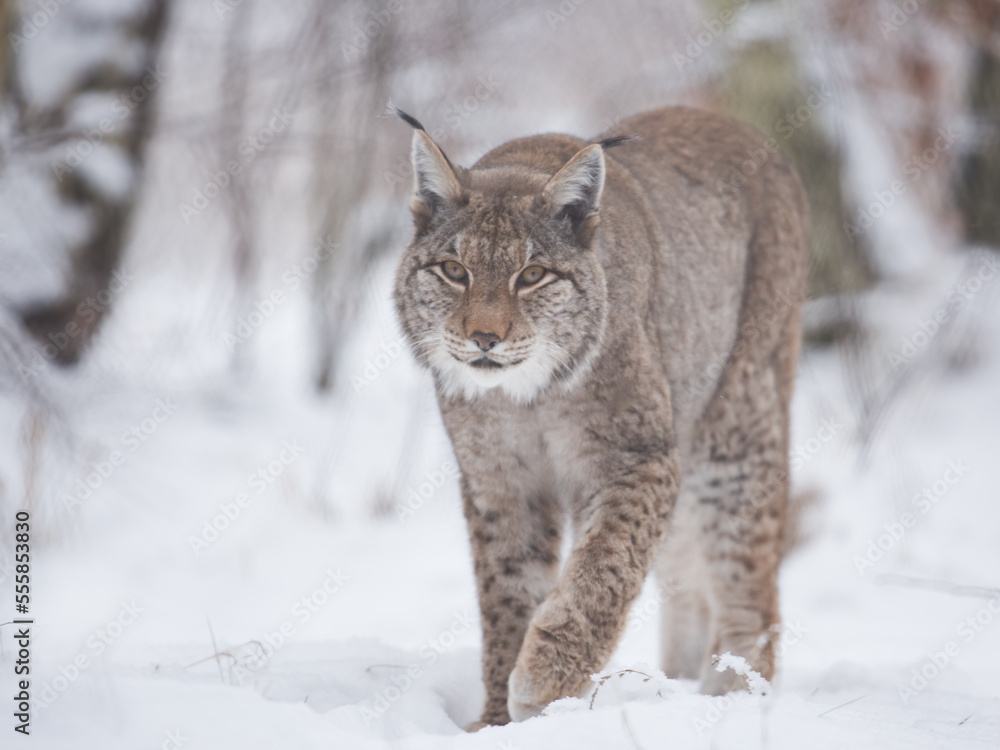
699, 357, 788, 695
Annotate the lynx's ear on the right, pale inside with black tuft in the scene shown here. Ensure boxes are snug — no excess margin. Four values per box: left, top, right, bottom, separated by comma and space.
542, 143, 604, 241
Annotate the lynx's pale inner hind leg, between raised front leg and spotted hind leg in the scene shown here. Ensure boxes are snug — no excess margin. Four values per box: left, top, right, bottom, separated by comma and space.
656, 506, 709, 679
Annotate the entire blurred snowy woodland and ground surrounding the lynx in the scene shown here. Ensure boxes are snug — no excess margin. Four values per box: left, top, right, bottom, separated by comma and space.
0, 0, 1000, 750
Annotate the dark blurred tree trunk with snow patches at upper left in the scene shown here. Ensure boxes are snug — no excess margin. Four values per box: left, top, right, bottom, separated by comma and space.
18, 0, 169, 364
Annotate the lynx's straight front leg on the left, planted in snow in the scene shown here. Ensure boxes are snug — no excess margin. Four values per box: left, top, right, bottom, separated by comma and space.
463, 492, 561, 724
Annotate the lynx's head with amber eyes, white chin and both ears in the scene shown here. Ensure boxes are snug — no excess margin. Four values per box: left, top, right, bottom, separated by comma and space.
395, 131, 607, 403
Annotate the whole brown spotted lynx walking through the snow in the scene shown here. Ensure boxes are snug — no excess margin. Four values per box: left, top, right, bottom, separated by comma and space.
394, 107, 808, 725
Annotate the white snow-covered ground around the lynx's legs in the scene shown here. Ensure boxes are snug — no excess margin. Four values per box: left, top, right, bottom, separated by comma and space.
0, 253, 1000, 750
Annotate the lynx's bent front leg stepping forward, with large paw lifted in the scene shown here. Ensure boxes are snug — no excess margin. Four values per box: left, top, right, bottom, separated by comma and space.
508, 460, 677, 721
